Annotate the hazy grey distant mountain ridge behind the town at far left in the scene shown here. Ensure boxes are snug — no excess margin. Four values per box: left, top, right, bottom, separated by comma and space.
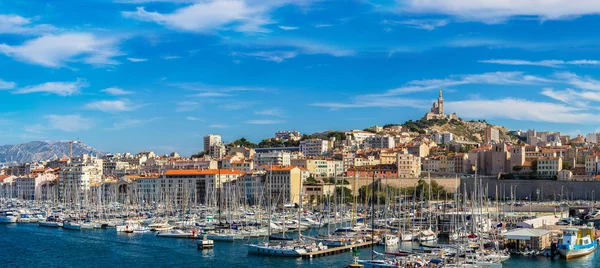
0, 141, 106, 165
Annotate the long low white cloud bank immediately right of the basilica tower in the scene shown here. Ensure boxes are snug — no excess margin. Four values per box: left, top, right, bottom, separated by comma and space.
445, 98, 600, 124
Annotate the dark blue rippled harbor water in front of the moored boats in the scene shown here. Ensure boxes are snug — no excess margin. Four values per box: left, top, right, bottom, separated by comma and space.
0, 224, 600, 268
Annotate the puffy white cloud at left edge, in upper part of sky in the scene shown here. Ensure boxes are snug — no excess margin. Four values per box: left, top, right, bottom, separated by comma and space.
0, 33, 122, 68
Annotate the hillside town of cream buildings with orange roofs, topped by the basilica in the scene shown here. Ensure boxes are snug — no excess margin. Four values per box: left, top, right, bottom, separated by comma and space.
0, 91, 600, 204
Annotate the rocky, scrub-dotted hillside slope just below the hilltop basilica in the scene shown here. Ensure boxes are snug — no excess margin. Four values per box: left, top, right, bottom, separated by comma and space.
388, 119, 519, 143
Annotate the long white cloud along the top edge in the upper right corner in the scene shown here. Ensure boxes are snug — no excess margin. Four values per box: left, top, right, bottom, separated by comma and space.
401, 0, 600, 23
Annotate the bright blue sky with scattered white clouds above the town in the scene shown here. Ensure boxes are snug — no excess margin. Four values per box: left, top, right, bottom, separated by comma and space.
0, 0, 600, 155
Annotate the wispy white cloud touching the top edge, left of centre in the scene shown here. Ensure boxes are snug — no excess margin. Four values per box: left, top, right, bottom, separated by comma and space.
121, 0, 273, 33
